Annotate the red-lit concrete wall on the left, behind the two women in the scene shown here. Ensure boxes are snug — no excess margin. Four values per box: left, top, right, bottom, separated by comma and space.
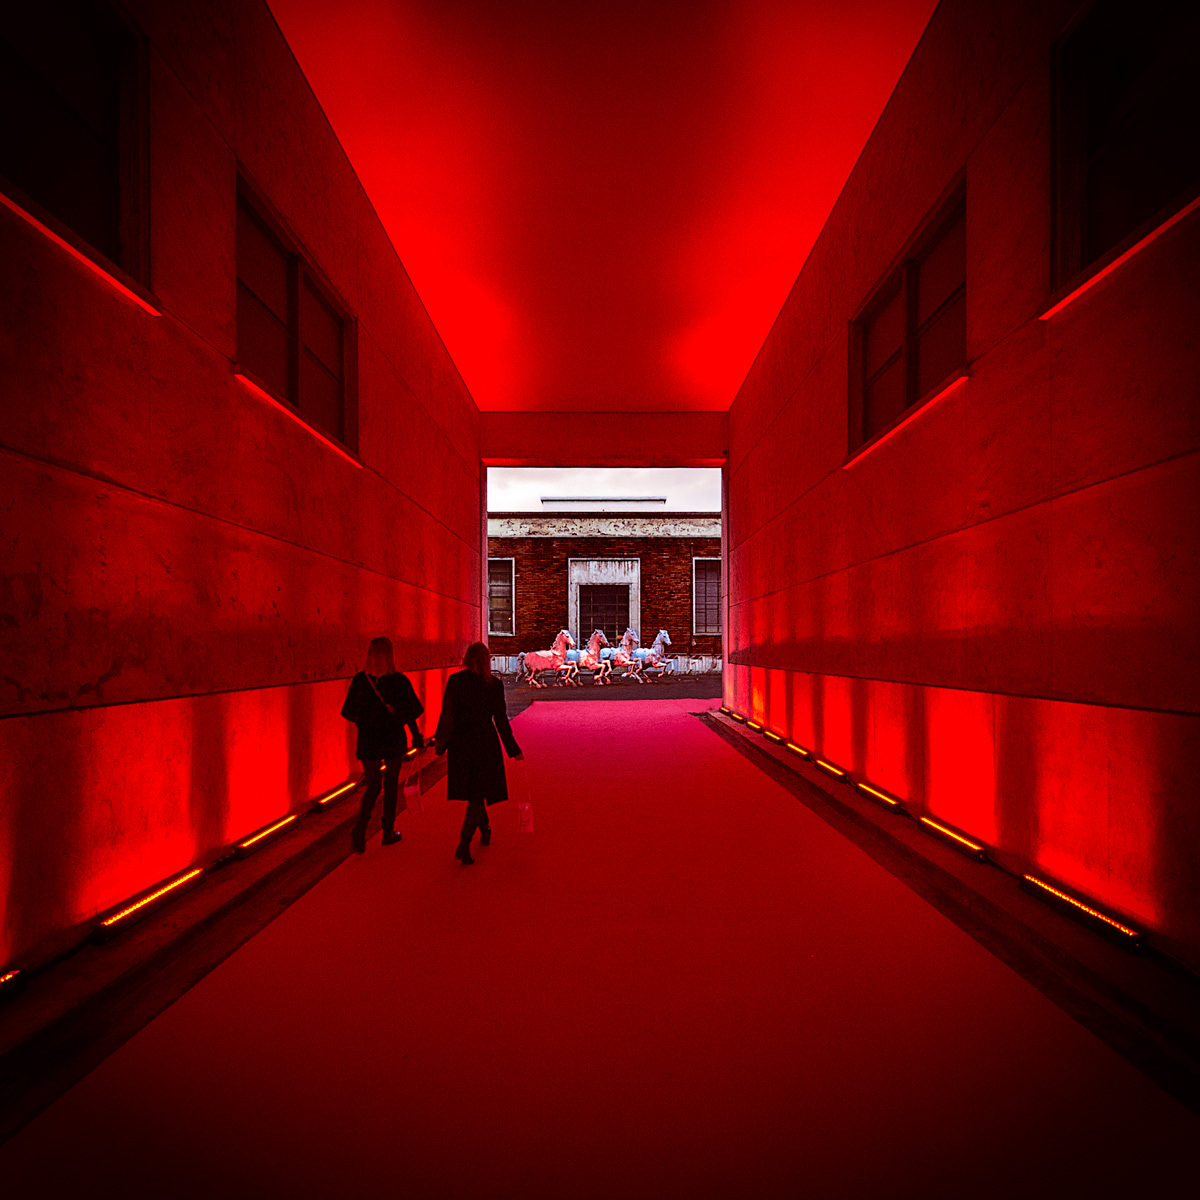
0, 0, 482, 964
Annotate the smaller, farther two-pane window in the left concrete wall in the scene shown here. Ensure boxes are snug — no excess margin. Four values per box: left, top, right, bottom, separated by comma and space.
238, 196, 347, 442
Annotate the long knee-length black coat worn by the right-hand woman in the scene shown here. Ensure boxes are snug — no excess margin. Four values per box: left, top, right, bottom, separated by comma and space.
434, 671, 521, 804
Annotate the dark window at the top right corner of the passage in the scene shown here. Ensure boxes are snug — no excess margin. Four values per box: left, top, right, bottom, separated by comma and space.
1055, 0, 1200, 286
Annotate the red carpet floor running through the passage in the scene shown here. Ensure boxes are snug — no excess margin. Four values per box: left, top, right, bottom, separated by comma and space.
0, 700, 1200, 1200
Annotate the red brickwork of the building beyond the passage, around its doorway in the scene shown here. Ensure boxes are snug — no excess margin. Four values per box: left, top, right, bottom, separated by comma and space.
487, 538, 721, 655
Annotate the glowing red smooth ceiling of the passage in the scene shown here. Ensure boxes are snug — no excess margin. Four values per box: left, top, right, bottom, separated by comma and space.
270, 0, 935, 410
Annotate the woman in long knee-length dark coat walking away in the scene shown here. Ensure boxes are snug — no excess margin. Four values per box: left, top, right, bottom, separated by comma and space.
433, 642, 524, 866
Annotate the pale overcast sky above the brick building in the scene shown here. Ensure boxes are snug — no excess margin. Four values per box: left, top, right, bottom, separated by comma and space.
487, 467, 721, 512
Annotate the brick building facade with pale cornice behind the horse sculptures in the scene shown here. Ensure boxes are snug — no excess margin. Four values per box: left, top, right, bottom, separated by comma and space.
487, 512, 721, 658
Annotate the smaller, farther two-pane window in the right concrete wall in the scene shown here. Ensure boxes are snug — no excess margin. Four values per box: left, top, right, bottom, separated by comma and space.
845, 191, 967, 466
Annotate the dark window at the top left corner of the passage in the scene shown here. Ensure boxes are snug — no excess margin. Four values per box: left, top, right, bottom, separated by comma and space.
0, 0, 145, 278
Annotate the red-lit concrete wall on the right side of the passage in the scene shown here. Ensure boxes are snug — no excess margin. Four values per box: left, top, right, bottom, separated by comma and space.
726, 0, 1200, 966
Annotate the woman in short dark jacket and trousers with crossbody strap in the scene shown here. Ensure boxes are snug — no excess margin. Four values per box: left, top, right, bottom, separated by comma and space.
342, 637, 425, 854
